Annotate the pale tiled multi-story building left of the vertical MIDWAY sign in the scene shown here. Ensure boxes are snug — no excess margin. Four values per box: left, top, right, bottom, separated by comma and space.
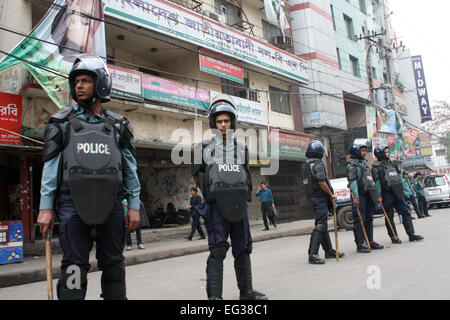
290, 0, 391, 177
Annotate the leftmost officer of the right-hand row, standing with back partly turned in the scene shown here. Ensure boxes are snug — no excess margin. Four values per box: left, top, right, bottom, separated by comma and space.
302, 140, 344, 264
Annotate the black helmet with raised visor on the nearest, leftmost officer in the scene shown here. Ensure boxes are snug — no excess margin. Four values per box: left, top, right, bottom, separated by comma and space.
69, 54, 112, 102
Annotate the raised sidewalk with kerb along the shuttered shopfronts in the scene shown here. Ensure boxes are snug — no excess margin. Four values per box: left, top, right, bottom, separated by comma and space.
0, 220, 324, 288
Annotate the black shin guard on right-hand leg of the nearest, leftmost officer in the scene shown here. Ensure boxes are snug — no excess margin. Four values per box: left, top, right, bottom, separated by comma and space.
100, 260, 127, 300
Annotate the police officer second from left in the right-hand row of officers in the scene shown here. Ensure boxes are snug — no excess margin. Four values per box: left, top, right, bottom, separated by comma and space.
347, 139, 384, 253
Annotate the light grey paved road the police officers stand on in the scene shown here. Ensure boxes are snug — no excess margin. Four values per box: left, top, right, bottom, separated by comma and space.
0, 208, 450, 300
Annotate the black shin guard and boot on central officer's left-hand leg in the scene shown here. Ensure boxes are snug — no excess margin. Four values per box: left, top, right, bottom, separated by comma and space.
206, 245, 228, 300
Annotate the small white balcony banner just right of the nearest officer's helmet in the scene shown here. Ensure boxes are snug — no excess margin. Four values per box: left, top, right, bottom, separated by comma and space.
108, 65, 144, 101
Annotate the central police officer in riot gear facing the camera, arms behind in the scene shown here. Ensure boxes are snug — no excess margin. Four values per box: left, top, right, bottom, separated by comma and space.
192, 95, 267, 300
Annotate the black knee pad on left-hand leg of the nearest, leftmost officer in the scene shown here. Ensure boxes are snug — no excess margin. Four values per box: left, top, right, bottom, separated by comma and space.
56, 265, 87, 300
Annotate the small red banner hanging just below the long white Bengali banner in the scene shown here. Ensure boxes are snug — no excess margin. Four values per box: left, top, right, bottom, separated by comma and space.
199, 51, 244, 84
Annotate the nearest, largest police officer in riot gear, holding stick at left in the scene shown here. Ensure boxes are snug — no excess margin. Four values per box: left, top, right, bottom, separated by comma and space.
37, 54, 140, 300
